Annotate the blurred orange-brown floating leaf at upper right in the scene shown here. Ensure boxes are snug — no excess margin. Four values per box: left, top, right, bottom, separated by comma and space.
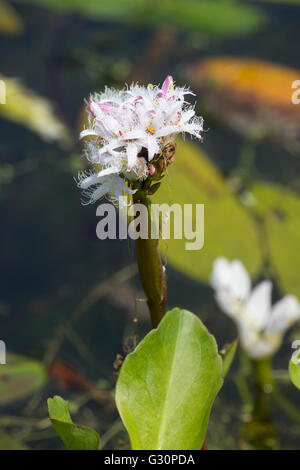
187, 57, 300, 151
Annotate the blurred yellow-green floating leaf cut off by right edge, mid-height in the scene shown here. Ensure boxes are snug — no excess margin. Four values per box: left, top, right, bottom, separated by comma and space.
252, 182, 300, 299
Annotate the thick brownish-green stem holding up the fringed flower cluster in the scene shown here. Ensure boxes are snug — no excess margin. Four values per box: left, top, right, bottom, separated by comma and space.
133, 191, 167, 328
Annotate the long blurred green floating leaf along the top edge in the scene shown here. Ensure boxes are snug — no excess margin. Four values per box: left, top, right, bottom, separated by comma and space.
14, 0, 266, 35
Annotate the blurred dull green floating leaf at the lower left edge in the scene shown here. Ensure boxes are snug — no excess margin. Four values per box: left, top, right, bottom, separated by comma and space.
0, 354, 47, 405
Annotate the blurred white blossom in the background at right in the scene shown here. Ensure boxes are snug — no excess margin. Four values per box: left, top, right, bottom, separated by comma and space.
210, 258, 300, 359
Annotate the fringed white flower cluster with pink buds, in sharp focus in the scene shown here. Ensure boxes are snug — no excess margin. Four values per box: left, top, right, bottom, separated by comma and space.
78, 76, 203, 203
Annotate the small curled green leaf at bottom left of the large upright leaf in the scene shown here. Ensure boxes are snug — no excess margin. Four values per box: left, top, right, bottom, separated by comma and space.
48, 396, 100, 450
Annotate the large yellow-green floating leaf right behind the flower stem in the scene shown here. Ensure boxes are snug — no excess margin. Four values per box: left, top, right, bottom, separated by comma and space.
151, 139, 262, 282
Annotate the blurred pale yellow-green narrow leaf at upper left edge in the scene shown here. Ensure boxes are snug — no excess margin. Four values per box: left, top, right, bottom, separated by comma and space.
0, 75, 70, 143
